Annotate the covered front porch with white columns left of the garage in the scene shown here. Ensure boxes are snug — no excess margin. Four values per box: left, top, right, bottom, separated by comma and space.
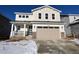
11, 24, 32, 37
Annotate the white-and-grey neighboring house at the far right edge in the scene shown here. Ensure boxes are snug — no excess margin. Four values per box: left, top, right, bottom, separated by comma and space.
69, 14, 79, 38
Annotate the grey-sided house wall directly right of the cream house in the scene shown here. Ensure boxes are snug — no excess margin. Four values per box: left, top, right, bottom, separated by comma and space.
60, 14, 72, 36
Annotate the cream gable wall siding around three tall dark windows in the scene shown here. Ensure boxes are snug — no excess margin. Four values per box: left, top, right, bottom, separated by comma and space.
33, 8, 60, 21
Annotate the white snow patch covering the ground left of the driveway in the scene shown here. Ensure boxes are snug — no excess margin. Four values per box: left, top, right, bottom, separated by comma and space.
0, 40, 37, 54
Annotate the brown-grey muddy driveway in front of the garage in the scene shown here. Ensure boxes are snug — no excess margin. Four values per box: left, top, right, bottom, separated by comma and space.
36, 40, 79, 54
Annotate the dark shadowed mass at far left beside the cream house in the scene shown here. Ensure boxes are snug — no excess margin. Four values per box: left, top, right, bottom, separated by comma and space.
0, 14, 11, 40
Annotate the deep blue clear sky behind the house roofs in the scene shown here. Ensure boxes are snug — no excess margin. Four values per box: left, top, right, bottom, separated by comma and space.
0, 5, 79, 20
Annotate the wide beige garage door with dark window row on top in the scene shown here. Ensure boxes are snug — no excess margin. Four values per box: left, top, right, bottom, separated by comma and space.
36, 26, 60, 40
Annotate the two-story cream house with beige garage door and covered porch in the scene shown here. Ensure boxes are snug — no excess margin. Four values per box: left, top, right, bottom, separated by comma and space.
10, 6, 66, 40
